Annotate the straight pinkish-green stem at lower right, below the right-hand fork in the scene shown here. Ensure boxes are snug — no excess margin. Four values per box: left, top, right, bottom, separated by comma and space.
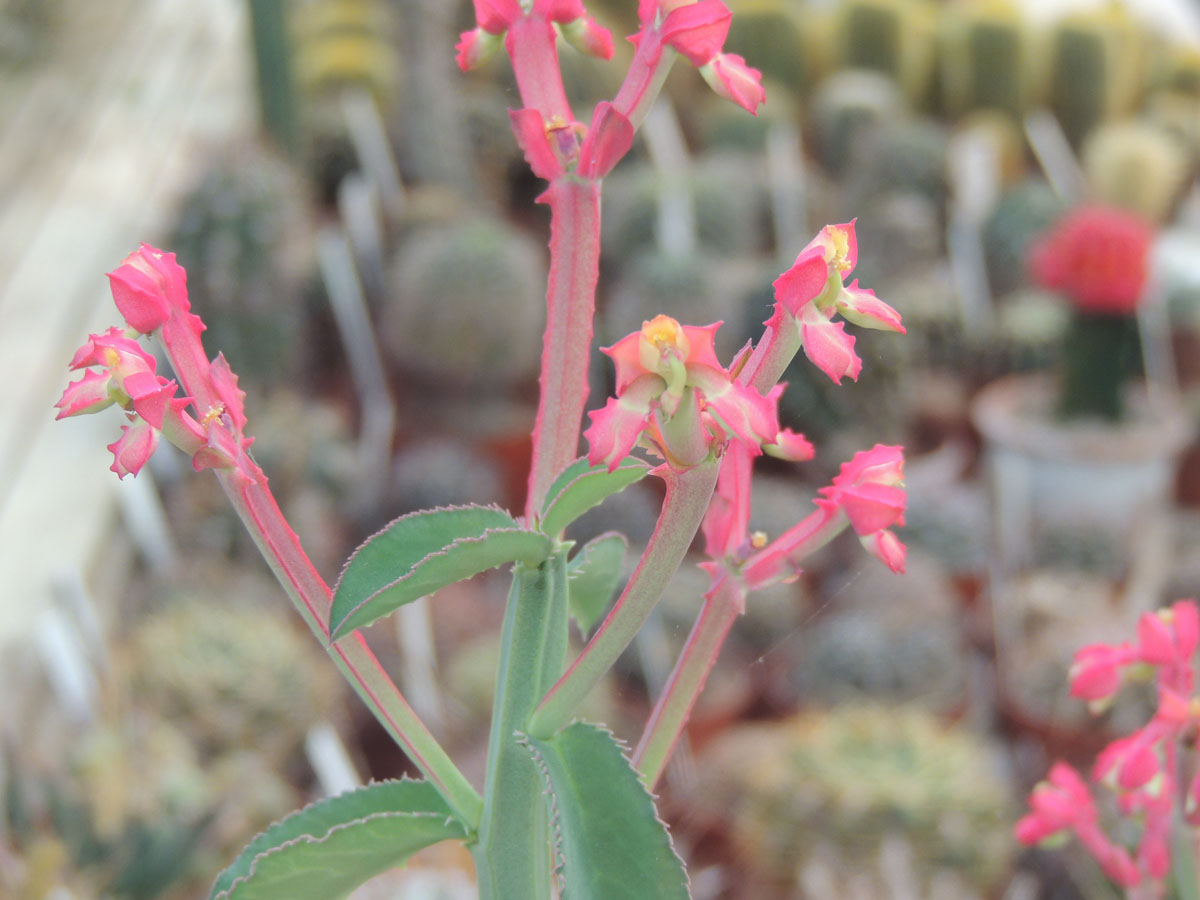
634, 577, 745, 790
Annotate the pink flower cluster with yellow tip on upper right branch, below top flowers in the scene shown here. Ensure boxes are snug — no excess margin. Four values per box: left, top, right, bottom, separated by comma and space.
766, 221, 905, 384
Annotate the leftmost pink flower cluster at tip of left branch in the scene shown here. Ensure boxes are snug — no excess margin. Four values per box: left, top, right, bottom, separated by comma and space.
56, 244, 253, 478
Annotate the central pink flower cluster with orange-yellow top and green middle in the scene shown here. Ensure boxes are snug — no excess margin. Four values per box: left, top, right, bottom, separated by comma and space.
584, 316, 782, 469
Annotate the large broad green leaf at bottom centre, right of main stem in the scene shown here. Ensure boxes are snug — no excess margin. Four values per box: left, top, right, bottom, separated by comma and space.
526, 722, 691, 900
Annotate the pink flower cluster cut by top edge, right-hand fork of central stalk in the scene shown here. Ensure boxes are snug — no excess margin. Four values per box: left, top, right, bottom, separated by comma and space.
629, 0, 767, 114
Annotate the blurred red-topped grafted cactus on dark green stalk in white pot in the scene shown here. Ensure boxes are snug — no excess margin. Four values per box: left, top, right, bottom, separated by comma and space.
1032, 206, 1153, 420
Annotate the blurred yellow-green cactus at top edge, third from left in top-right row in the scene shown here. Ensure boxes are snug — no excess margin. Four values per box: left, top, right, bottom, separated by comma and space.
940, 0, 1037, 118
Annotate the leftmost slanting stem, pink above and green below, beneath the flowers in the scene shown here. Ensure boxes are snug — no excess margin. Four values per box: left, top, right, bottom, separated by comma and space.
217, 467, 482, 828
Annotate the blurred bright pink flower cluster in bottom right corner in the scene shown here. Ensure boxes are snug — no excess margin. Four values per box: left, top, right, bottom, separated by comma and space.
1016, 600, 1200, 896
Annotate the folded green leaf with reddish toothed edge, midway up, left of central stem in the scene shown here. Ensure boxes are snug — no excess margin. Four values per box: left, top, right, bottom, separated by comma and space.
329, 506, 551, 640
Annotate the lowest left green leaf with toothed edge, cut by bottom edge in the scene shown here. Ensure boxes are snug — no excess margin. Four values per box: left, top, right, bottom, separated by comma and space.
209, 781, 467, 900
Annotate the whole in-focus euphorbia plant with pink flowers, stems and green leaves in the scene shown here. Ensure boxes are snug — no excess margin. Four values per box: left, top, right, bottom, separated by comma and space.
59, 0, 905, 900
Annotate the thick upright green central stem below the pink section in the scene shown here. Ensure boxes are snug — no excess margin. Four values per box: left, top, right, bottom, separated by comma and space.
472, 550, 568, 900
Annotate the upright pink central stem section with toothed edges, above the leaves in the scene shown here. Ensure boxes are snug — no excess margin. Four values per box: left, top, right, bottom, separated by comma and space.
526, 179, 600, 521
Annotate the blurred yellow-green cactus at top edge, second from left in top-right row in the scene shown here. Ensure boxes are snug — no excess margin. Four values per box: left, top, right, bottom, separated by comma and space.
834, 0, 937, 104
